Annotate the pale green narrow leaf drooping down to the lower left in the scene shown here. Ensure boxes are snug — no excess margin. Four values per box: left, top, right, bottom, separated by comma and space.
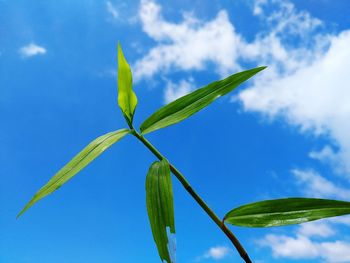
17, 129, 130, 218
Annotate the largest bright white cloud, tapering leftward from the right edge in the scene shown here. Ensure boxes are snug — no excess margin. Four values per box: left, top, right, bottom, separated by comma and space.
239, 28, 350, 134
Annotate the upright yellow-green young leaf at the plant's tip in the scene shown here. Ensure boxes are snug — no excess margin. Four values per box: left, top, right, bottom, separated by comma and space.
118, 43, 137, 125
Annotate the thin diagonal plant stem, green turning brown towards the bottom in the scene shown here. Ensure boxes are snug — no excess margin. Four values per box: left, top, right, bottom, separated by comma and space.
132, 129, 252, 263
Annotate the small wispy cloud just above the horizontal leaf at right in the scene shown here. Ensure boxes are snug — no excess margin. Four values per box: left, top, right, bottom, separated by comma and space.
292, 169, 350, 199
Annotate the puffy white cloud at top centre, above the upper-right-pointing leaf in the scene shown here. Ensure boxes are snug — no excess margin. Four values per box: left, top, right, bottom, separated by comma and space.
135, 0, 240, 80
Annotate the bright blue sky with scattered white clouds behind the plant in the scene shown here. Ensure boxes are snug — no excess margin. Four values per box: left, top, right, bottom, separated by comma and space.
0, 0, 350, 263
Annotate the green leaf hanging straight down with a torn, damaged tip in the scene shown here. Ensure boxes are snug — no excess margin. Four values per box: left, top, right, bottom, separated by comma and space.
146, 160, 175, 263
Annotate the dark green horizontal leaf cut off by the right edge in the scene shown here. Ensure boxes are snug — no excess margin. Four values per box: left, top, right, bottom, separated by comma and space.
224, 198, 350, 227
